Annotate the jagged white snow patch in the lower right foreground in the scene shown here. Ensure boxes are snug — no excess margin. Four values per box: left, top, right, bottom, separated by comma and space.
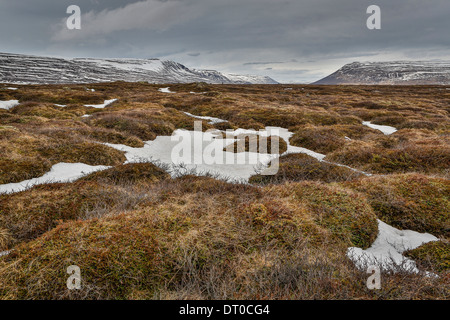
347, 220, 439, 273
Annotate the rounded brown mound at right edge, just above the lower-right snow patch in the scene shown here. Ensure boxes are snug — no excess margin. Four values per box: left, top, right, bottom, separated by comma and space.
343, 174, 450, 238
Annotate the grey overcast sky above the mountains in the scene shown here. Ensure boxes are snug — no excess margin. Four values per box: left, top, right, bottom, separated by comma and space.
0, 0, 450, 83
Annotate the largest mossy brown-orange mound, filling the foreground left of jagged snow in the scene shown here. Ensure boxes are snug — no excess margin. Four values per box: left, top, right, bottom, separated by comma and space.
0, 177, 384, 299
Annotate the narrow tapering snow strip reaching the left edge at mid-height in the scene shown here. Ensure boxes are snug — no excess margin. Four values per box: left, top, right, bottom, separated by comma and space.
0, 162, 110, 194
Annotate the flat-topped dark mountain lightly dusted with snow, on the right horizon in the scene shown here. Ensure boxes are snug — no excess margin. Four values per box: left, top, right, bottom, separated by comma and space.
315, 61, 450, 85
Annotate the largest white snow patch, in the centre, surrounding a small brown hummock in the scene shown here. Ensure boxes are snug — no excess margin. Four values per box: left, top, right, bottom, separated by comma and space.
105, 127, 367, 182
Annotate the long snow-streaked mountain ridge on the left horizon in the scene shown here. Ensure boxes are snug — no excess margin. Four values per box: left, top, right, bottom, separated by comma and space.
0, 53, 277, 84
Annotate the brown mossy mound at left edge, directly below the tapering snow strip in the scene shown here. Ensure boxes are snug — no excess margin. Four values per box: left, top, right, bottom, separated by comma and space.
0, 163, 169, 245
